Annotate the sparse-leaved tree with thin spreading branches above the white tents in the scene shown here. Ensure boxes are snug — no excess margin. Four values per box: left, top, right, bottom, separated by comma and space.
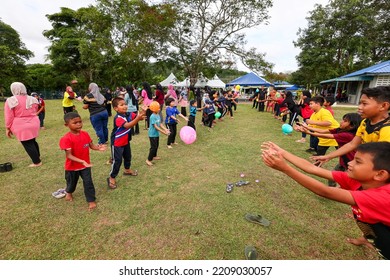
166, 0, 272, 82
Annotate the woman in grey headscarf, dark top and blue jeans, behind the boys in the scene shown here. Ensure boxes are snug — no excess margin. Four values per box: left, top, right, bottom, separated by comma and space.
83, 83, 108, 145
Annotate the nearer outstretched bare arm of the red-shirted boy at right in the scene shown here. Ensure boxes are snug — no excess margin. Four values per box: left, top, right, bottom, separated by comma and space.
262, 147, 356, 205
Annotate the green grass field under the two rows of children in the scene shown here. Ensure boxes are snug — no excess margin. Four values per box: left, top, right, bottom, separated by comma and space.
0, 100, 376, 260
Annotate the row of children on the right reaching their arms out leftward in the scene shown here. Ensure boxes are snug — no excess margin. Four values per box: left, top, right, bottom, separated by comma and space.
262, 86, 390, 259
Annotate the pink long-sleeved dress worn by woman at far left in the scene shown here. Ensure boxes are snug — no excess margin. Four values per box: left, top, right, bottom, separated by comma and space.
4, 95, 39, 141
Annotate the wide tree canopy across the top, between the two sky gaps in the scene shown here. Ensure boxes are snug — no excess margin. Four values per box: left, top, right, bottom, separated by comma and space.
44, 0, 272, 85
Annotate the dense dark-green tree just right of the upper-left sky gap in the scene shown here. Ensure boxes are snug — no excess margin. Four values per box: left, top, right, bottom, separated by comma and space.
43, 6, 113, 83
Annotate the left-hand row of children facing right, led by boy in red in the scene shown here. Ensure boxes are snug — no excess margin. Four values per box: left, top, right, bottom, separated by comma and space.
60, 84, 241, 210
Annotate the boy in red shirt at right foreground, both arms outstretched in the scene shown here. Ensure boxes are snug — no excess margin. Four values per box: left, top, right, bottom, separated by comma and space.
262, 142, 390, 259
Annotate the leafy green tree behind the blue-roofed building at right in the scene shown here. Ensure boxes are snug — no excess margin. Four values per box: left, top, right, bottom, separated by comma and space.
293, 0, 390, 84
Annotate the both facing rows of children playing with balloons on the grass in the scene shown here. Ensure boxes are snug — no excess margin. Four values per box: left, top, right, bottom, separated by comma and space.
55, 80, 390, 259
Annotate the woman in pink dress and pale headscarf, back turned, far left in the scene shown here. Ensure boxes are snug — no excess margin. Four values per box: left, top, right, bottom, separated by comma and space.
4, 82, 42, 167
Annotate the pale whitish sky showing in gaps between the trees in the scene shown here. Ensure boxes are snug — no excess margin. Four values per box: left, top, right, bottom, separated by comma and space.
0, 0, 329, 72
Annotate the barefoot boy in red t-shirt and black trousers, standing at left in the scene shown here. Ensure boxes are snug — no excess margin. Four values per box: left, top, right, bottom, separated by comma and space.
60, 112, 107, 210
